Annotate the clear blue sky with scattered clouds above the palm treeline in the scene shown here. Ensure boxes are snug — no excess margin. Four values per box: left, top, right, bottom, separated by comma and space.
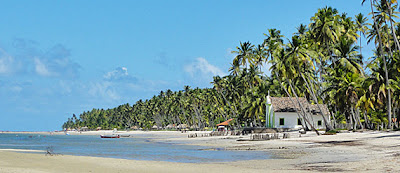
0, 0, 369, 131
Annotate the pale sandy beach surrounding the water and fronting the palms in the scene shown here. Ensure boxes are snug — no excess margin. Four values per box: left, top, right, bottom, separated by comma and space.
0, 131, 400, 173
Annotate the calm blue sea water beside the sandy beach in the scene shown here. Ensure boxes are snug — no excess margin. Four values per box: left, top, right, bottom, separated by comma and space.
0, 133, 270, 163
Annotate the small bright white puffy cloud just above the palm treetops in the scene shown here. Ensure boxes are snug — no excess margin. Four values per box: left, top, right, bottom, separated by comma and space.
184, 57, 226, 77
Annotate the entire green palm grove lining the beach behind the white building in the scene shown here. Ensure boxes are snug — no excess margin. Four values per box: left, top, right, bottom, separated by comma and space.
63, 0, 400, 132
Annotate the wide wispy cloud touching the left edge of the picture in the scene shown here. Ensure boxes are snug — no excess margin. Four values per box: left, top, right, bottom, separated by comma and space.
0, 39, 81, 79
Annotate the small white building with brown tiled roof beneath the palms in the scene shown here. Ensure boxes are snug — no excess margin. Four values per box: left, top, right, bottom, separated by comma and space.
266, 96, 330, 129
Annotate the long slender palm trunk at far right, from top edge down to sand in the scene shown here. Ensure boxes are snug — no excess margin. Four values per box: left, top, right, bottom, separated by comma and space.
370, 0, 393, 129
